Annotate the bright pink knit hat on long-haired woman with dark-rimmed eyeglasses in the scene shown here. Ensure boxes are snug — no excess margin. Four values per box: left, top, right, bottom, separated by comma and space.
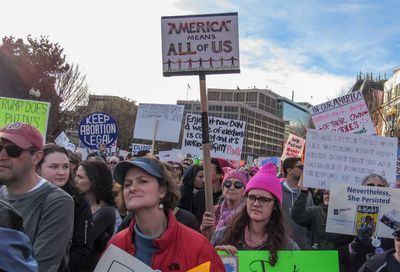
245, 162, 282, 204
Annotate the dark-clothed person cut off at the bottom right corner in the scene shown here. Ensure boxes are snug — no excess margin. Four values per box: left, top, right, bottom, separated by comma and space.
358, 225, 400, 272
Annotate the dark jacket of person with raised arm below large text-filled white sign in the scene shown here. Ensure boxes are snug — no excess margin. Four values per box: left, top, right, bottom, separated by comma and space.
291, 191, 354, 250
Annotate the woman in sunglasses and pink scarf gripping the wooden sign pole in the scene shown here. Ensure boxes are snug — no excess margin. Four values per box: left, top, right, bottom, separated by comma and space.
200, 170, 247, 239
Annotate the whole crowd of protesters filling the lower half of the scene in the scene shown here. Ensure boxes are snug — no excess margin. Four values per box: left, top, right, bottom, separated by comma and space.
0, 123, 400, 272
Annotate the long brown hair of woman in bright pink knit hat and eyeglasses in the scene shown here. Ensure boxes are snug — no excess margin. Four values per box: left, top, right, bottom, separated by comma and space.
219, 199, 288, 266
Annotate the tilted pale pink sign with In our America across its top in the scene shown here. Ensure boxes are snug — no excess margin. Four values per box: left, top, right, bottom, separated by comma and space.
309, 91, 376, 135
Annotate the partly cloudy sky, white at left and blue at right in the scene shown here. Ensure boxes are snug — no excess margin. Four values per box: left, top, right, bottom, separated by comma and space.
0, 0, 400, 104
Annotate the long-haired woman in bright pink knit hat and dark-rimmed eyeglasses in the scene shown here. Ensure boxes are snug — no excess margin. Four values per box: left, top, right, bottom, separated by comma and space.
211, 163, 299, 266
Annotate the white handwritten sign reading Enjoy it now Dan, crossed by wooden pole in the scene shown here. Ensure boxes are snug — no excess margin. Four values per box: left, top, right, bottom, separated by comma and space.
182, 114, 246, 161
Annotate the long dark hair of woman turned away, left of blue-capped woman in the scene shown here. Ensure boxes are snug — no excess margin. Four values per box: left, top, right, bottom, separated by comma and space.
80, 160, 115, 206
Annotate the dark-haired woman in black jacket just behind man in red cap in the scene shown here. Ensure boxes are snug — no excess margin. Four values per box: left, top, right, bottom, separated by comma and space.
37, 144, 93, 271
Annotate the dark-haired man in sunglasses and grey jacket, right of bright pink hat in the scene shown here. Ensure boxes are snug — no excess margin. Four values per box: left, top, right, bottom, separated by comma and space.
282, 158, 314, 249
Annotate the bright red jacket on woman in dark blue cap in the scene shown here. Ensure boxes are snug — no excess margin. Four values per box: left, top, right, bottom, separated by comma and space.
107, 211, 225, 272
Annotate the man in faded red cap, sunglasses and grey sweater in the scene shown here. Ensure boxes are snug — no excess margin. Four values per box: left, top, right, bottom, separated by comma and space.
0, 122, 74, 271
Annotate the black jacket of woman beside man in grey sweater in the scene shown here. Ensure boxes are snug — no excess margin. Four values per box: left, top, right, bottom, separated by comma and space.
68, 193, 93, 271
